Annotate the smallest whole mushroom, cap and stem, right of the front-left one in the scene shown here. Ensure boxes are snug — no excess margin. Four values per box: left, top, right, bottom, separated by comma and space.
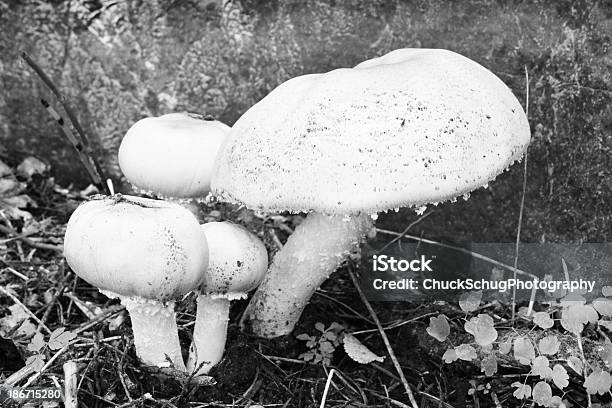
187, 221, 268, 374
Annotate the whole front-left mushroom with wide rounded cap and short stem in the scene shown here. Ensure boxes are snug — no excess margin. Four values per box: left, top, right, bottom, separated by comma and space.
64, 195, 208, 370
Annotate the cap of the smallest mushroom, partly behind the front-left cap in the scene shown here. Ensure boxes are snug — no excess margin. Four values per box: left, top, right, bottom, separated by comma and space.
200, 221, 268, 299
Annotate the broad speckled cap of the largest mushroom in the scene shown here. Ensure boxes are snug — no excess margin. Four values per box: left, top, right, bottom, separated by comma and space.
212, 49, 530, 214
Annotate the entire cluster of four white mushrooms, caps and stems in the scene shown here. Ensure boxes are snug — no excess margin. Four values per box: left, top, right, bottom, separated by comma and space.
65, 49, 530, 374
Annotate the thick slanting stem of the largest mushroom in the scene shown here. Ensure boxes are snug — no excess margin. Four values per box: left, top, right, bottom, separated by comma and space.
241, 212, 372, 338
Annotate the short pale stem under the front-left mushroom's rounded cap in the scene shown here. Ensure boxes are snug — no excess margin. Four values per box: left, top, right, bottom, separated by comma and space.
120, 296, 185, 371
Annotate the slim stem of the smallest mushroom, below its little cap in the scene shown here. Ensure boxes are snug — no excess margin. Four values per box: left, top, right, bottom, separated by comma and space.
187, 295, 230, 375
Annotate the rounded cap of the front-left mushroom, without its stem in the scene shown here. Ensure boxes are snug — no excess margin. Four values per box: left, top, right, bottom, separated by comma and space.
64, 195, 208, 301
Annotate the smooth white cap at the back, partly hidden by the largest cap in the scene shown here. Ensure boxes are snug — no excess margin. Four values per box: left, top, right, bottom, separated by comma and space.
119, 113, 230, 197
